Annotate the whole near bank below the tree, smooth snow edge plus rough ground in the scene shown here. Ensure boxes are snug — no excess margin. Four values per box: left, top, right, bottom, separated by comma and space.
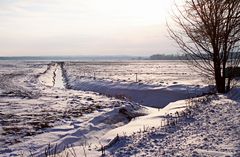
54, 89, 240, 157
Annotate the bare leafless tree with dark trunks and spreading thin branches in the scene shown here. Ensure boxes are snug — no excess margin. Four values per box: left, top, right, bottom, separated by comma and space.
168, 0, 240, 93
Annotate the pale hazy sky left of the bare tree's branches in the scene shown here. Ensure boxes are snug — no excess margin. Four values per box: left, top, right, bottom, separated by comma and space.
0, 0, 176, 56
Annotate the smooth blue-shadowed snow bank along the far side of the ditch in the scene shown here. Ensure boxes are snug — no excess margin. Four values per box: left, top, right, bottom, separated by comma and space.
69, 77, 210, 108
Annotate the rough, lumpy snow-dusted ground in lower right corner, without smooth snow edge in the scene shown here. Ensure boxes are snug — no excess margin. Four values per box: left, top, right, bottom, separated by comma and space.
109, 90, 240, 157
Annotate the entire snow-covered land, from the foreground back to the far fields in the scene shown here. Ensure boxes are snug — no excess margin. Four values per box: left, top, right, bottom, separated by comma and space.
0, 61, 240, 157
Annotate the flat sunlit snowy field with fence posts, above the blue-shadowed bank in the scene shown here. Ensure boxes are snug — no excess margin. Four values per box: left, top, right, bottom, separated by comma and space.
65, 61, 202, 85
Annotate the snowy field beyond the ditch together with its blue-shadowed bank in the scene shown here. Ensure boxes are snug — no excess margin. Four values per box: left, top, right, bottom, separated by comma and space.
64, 61, 209, 108
